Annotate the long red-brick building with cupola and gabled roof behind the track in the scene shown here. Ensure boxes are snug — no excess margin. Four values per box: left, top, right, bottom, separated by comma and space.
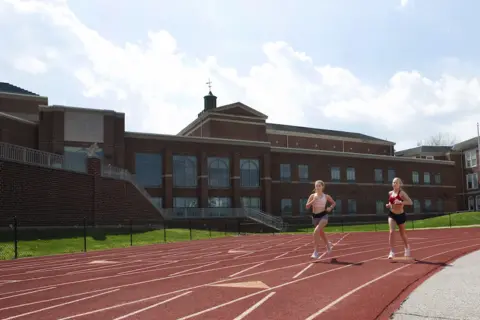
0, 83, 466, 225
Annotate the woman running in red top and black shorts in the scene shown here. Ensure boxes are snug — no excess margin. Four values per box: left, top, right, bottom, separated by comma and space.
386, 178, 413, 259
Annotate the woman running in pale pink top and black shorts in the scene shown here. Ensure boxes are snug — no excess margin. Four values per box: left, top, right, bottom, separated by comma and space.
306, 180, 335, 259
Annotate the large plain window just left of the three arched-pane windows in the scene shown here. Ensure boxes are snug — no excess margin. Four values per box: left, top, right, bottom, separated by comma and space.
135, 153, 162, 188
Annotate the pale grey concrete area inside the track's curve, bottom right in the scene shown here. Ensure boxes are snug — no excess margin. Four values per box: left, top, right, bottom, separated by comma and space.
391, 250, 480, 320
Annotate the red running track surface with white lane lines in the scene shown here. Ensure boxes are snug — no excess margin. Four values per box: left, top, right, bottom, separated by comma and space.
0, 228, 480, 320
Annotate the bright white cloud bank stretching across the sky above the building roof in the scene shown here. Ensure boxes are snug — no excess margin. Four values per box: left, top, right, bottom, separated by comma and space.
0, 0, 480, 149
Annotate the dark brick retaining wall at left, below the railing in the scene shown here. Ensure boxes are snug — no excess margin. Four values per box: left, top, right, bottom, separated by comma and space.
0, 161, 161, 226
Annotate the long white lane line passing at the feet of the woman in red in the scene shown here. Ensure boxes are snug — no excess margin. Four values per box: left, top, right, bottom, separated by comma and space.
177, 239, 480, 320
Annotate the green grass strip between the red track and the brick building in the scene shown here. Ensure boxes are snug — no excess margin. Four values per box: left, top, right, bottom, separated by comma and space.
0, 212, 480, 260
